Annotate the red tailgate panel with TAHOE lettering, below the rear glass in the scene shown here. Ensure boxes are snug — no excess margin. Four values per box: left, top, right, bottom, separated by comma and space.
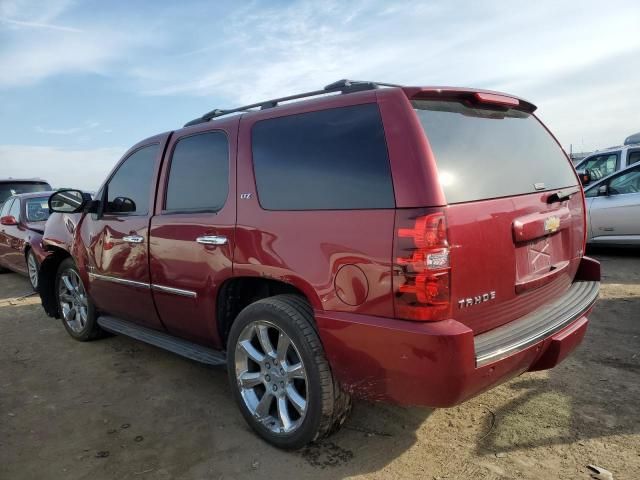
447, 193, 584, 334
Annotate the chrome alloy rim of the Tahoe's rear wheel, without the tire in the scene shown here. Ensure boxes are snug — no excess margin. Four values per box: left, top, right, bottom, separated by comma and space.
235, 320, 309, 434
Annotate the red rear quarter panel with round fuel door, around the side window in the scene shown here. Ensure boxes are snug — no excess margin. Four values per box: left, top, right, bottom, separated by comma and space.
234, 92, 394, 317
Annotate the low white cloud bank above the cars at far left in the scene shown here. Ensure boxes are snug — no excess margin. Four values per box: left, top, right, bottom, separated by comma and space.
0, 145, 126, 191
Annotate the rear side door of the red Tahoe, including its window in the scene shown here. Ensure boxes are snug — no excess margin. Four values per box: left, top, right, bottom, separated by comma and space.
150, 118, 238, 348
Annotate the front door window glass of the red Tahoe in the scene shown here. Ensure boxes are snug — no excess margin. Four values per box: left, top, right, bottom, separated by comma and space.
104, 144, 159, 215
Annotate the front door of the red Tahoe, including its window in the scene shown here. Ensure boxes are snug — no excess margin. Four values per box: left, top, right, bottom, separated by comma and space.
83, 135, 168, 329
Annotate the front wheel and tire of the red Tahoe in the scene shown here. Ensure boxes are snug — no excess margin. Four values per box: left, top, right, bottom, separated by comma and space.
55, 258, 104, 342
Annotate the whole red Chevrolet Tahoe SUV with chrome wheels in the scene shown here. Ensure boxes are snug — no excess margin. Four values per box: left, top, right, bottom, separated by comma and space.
39, 80, 600, 448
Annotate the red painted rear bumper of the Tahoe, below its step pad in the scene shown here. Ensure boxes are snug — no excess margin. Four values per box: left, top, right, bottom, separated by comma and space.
316, 311, 587, 407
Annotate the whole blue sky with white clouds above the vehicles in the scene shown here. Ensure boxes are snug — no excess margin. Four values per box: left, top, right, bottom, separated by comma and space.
0, 0, 640, 190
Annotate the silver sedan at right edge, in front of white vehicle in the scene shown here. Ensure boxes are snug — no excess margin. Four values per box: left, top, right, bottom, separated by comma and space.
584, 162, 640, 246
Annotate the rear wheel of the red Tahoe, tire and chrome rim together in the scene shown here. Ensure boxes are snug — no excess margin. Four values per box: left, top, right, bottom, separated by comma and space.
227, 295, 351, 449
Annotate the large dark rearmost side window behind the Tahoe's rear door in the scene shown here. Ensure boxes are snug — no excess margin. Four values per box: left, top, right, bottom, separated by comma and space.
252, 104, 395, 210
